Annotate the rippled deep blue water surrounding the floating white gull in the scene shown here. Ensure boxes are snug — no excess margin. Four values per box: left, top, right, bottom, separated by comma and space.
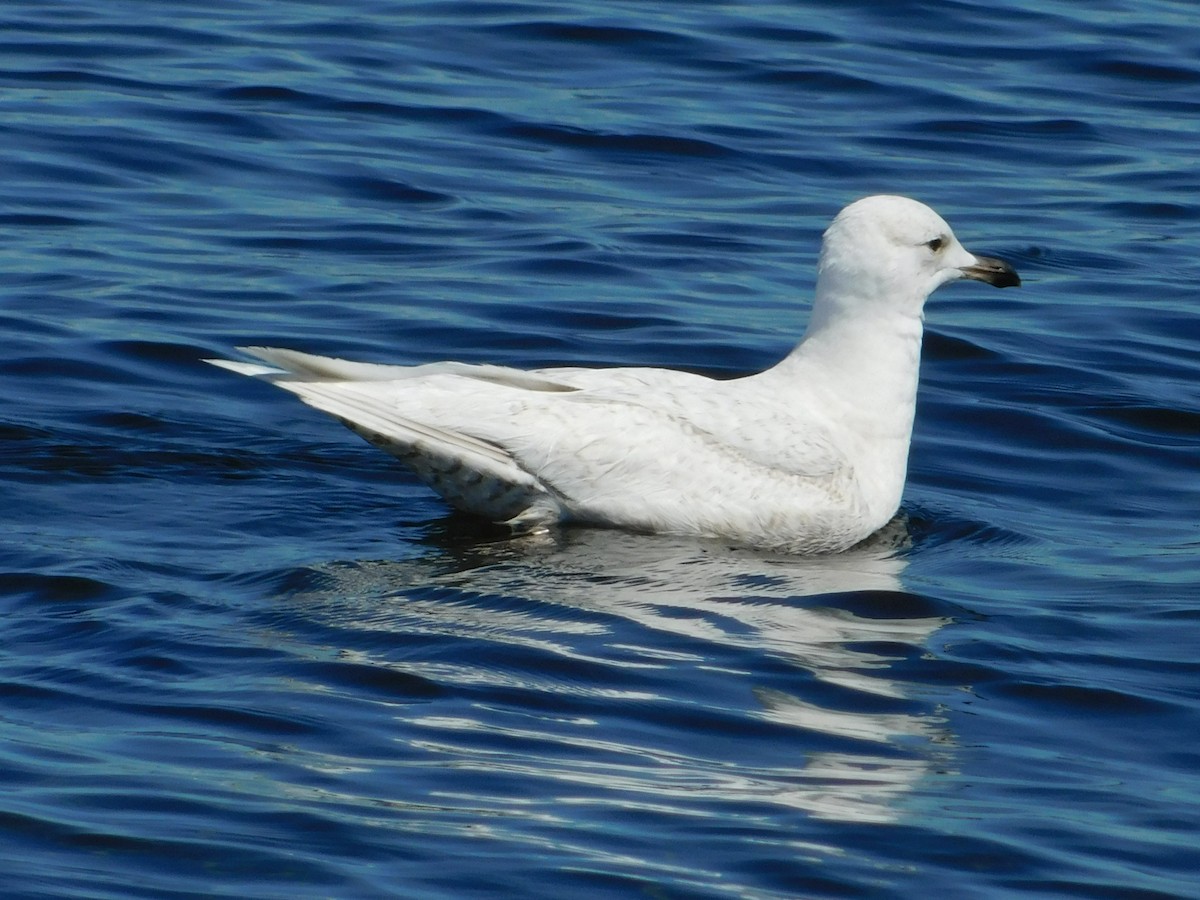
0, 0, 1200, 900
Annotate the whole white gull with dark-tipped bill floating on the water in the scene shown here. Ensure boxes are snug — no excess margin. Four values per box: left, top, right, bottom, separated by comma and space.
209, 196, 1020, 553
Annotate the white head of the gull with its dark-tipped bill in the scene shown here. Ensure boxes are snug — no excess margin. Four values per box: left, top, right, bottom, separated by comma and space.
812, 194, 1021, 328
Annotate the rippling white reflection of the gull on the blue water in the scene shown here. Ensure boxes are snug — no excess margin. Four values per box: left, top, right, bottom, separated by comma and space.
283, 520, 952, 822
